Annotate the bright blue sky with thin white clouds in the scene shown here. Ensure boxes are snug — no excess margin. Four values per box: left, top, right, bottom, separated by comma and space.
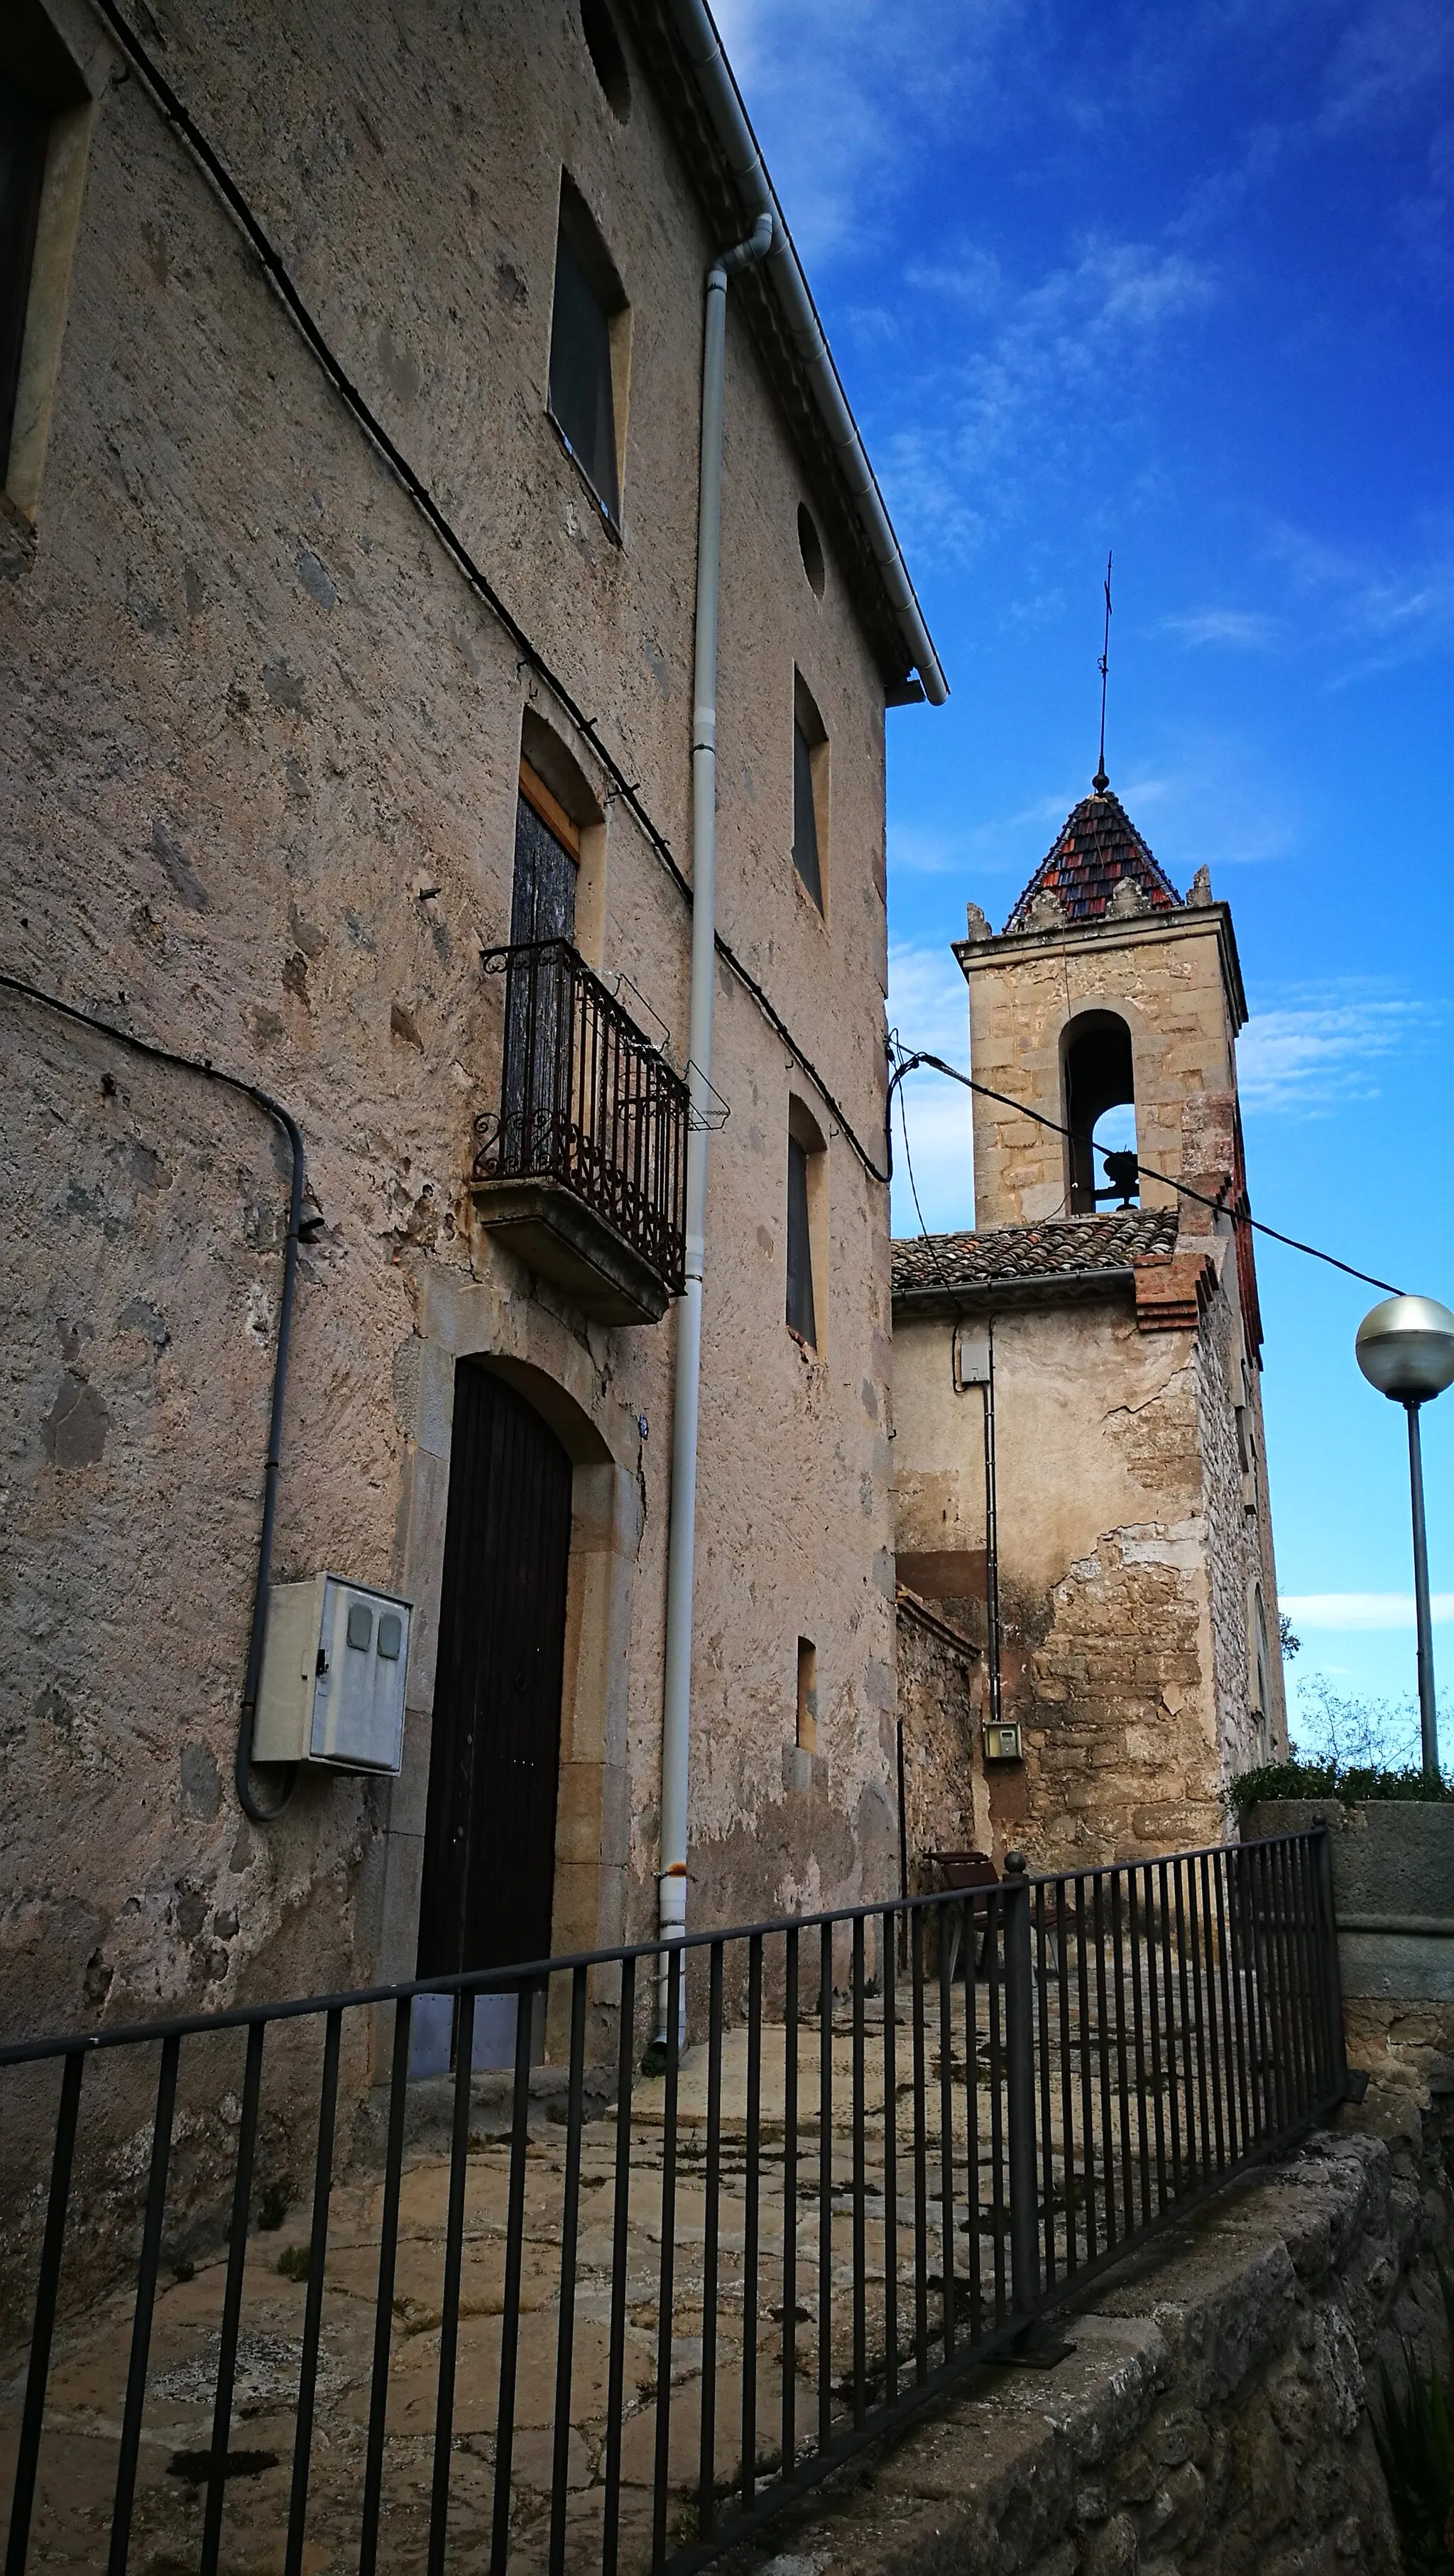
719, 0, 1454, 1752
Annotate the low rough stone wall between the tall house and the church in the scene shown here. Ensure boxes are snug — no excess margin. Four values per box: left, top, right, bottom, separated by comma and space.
897, 1592, 1003, 1896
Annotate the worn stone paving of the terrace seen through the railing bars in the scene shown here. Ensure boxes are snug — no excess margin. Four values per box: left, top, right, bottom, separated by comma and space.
0, 1989, 1247, 2576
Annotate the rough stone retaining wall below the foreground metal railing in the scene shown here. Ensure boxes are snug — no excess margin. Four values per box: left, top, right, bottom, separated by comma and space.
732, 2133, 1451, 2576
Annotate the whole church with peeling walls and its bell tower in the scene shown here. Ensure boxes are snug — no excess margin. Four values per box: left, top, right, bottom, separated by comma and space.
895, 775, 1286, 1867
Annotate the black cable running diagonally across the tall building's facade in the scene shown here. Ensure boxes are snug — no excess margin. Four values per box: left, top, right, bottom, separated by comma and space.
95, 0, 890, 1188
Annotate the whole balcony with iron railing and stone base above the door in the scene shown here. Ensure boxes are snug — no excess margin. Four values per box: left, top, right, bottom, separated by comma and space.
474, 940, 689, 1324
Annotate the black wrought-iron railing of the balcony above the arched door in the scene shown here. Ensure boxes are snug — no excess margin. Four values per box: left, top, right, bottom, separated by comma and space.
474, 940, 689, 1296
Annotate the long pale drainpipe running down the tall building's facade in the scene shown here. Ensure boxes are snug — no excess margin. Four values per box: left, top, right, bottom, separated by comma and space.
657, 214, 773, 2038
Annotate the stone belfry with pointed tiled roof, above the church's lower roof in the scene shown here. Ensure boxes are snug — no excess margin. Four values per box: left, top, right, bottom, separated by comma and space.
954, 768, 1248, 1252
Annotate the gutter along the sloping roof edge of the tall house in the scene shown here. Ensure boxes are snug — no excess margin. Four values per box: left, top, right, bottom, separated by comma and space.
665, 0, 949, 706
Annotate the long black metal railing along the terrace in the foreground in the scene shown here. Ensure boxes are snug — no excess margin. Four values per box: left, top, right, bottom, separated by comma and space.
0, 1832, 1345, 2576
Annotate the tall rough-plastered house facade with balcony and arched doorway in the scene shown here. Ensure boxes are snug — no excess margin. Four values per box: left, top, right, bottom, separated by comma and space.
0, 0, 941, 2030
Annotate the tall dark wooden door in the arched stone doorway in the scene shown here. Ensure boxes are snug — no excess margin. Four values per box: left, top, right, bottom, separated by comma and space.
417, 1360, 569, 1976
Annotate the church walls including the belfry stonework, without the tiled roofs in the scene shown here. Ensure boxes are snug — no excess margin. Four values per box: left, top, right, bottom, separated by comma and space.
895, 855, 1286, 1867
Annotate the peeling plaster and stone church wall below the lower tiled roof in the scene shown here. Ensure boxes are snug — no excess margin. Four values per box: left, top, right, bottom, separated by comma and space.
895, 1296, 1276, 1867
